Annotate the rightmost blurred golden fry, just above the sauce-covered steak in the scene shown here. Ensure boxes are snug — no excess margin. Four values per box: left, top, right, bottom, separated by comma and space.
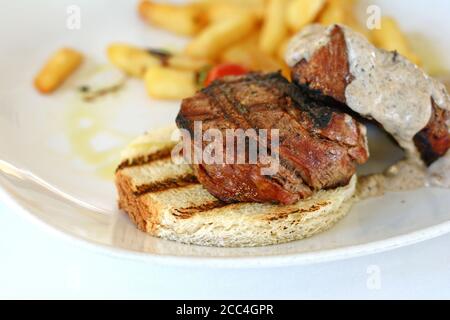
372, 17, 421, 65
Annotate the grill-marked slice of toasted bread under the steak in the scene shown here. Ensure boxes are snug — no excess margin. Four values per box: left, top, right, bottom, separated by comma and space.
116, 126, 356, 247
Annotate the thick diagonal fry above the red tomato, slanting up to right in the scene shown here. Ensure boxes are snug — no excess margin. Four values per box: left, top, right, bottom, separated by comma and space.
186, 14, 256, 60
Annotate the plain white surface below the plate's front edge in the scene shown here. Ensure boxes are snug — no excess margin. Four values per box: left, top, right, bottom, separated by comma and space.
0, 204, 450, 299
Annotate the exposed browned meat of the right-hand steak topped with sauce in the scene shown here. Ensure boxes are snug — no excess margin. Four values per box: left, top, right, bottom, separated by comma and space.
292, 26, 450, 165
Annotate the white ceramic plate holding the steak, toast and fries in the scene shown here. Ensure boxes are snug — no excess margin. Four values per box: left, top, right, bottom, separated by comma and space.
0, 0, 450, 267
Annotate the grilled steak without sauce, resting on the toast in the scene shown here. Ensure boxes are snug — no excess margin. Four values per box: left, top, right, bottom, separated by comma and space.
176, 73, 368, 204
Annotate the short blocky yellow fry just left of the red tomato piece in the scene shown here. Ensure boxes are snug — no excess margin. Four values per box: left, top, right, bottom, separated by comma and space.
144, 66, 197, 100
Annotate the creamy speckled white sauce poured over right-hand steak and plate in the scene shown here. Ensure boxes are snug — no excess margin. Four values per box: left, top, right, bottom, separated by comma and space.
285, 25, 450, 194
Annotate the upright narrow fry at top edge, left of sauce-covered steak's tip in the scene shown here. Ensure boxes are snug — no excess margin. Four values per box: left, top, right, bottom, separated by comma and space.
259, 0, 287, 55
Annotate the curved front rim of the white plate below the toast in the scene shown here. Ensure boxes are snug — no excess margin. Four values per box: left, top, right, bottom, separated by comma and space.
0, 182, 450, 269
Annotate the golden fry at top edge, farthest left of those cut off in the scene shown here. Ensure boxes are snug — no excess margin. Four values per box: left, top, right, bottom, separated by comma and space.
138, 0, 207, 36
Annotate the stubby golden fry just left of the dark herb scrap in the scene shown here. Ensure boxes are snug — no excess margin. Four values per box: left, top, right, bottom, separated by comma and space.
107, 43, 161, 78
